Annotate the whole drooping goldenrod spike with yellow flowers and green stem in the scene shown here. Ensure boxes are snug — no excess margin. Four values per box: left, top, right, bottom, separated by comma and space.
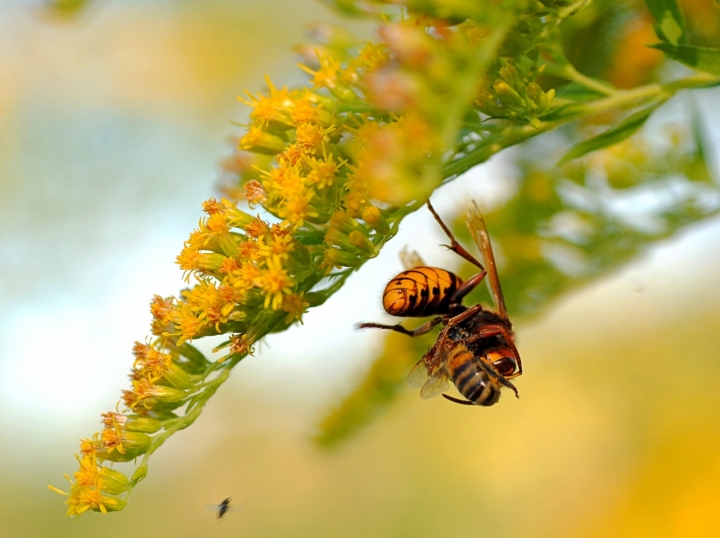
50, 0, 717, 516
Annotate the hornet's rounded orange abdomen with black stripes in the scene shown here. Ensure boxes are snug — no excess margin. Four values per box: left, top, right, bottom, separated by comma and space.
383, 267, 463, 317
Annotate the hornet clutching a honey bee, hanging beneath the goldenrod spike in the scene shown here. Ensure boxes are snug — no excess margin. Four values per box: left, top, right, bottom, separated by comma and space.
360, 201, 522, 406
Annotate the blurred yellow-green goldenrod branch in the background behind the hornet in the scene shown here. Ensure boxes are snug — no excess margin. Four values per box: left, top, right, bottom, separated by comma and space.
318, 111, 720, 445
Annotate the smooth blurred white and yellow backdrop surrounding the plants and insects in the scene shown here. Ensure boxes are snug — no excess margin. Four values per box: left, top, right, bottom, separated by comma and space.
0, 0, 720, 538
